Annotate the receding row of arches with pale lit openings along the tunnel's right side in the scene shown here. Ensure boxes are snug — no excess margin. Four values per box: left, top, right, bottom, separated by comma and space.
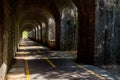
20, 5, 78, 50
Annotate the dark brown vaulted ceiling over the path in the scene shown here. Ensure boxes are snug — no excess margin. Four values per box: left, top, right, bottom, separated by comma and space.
9, 0, 73, 27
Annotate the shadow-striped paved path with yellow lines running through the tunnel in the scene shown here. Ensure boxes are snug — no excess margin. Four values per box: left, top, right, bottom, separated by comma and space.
7, 40, 120, 80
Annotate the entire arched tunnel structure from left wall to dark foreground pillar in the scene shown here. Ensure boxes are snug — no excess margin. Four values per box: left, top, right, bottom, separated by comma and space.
0, 0, 95, 78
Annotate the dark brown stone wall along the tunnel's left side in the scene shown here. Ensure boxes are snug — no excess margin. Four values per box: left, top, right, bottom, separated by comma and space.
0, 0, 15, 80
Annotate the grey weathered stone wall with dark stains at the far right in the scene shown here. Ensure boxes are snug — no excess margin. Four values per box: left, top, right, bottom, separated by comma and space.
95, 0, 120, 65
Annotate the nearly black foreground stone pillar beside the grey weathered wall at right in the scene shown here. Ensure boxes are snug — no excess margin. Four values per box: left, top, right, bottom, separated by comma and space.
74, 0, 95, 64
